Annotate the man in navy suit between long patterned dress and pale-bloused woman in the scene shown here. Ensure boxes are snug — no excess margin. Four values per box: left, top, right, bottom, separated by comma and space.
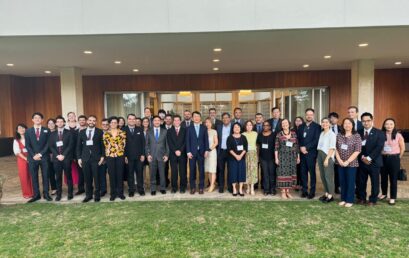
297, 108, 321, 199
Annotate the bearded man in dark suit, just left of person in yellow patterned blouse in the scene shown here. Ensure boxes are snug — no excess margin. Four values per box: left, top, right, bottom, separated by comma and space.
76, 115, 105, 202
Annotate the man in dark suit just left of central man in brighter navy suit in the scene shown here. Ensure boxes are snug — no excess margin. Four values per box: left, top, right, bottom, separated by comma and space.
167, 115, 187, 193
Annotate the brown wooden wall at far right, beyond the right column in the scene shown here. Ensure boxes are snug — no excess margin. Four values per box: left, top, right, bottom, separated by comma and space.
374, 69, 409, 129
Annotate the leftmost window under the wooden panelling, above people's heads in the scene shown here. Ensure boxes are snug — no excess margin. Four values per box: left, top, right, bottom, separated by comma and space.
105, 92, 144, 117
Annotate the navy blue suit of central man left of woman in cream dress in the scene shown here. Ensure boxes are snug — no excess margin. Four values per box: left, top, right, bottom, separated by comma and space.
186, 124, 209, 190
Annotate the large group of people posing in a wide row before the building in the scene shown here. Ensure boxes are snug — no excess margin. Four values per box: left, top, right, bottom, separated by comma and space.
14, 106, 405, 207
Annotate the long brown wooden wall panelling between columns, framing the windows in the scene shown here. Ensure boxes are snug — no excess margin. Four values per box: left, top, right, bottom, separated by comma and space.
83, 70, 351, 123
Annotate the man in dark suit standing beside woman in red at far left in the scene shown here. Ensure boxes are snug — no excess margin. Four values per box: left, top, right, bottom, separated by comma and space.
25, 112, 52, 202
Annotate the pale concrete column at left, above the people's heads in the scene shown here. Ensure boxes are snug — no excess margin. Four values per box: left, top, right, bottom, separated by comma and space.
60, 67, 84, 116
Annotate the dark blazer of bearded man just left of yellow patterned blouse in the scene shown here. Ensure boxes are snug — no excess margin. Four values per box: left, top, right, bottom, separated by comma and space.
76, 128, 105, 162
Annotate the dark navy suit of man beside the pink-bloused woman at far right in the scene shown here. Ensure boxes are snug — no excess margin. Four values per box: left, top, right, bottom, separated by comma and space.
357, 128, 386, 203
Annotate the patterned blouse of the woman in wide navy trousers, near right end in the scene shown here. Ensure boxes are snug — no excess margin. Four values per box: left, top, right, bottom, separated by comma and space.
337, 133, 362, 167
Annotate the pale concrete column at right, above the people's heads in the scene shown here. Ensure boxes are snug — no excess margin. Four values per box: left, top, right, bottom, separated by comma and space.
351, 60, 375, 114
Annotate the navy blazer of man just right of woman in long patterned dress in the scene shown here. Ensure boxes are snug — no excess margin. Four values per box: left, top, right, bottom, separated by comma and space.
297, 121, 321, 155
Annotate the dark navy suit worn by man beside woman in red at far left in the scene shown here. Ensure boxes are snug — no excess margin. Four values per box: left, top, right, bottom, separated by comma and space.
25, 127, 50, 197
